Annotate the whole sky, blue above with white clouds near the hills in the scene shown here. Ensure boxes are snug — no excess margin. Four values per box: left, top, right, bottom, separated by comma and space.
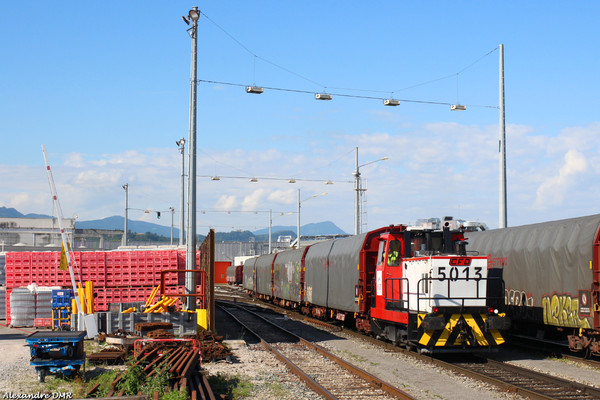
0, 1, 600, 233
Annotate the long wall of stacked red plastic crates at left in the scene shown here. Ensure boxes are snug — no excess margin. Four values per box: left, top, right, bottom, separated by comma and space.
6, 250, 201, 314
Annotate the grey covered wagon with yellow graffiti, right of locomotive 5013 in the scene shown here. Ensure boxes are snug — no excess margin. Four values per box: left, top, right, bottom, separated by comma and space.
465, 215, 600, 355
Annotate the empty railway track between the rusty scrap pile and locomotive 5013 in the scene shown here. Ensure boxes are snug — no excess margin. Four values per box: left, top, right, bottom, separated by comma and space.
217, 301, 414, 400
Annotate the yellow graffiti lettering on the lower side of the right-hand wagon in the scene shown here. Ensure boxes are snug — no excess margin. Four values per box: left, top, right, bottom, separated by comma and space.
542, 294, 591, 328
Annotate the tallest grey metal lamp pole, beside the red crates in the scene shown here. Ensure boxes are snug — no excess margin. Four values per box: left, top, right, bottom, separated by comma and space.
185, 7, 200, 311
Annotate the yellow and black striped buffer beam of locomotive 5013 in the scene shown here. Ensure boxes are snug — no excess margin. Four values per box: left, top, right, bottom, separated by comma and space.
417, 314, 504, 348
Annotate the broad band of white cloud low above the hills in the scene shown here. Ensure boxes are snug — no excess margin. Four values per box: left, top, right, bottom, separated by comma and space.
0, 122, 600, 232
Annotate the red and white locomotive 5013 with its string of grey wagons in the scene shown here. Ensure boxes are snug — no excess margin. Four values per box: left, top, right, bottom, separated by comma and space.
243, 225, 510, 353
